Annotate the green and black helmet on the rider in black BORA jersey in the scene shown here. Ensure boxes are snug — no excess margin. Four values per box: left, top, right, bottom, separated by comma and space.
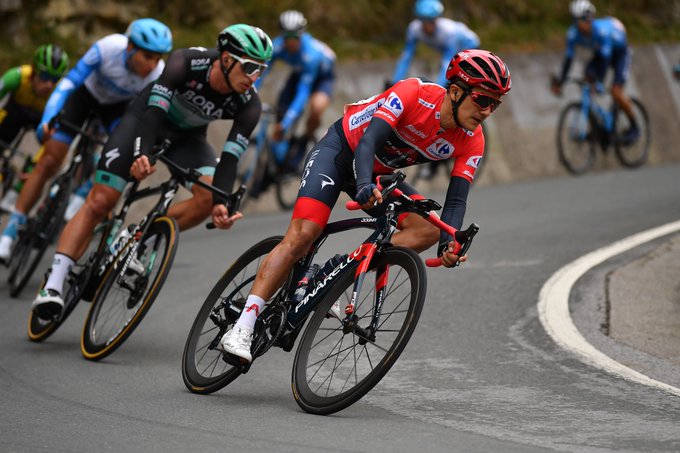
217, 24, 273, 61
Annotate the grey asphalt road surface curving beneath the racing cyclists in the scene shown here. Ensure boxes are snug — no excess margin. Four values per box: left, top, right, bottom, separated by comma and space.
0, 165, 680, 452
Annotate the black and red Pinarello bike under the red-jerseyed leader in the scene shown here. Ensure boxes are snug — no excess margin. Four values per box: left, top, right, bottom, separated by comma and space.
182, 172, 479, 414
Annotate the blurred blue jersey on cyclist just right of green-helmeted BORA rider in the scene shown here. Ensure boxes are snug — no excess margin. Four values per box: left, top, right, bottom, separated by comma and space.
255, 33, 335, 130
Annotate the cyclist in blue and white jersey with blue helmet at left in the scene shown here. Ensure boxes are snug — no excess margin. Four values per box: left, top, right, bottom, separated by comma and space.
0, 18, 172, 262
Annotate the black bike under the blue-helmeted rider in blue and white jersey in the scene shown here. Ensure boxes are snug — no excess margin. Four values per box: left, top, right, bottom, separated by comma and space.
8, 117, 104, 297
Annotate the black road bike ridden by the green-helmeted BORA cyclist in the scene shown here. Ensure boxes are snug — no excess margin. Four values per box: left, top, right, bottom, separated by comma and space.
28, 141, 245, 360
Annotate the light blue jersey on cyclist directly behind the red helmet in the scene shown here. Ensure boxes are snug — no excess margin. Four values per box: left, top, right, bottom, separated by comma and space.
392, 17, 479, 86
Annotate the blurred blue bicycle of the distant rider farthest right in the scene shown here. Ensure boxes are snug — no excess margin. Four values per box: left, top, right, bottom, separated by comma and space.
557, 80, 650, 175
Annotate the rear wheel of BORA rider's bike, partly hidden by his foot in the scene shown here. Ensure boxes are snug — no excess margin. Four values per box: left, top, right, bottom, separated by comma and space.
28, 223, 111, 343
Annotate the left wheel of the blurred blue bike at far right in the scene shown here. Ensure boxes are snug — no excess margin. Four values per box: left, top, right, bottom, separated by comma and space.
557, 102, 597, 175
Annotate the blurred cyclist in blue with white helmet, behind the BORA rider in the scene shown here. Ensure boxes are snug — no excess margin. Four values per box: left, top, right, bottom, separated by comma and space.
255, 10, 335, 168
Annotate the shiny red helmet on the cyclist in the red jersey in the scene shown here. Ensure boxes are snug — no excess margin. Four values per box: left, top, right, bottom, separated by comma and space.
446, 49, 512, 95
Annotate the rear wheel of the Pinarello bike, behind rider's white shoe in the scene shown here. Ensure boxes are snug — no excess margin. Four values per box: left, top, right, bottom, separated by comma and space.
182, 236, 283, 395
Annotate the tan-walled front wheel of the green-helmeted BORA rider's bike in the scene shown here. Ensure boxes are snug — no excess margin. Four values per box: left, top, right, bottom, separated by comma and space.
80, 216, 179, 361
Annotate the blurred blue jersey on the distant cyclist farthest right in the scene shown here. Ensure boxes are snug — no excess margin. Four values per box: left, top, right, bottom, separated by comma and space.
566, 17, 628, 60
